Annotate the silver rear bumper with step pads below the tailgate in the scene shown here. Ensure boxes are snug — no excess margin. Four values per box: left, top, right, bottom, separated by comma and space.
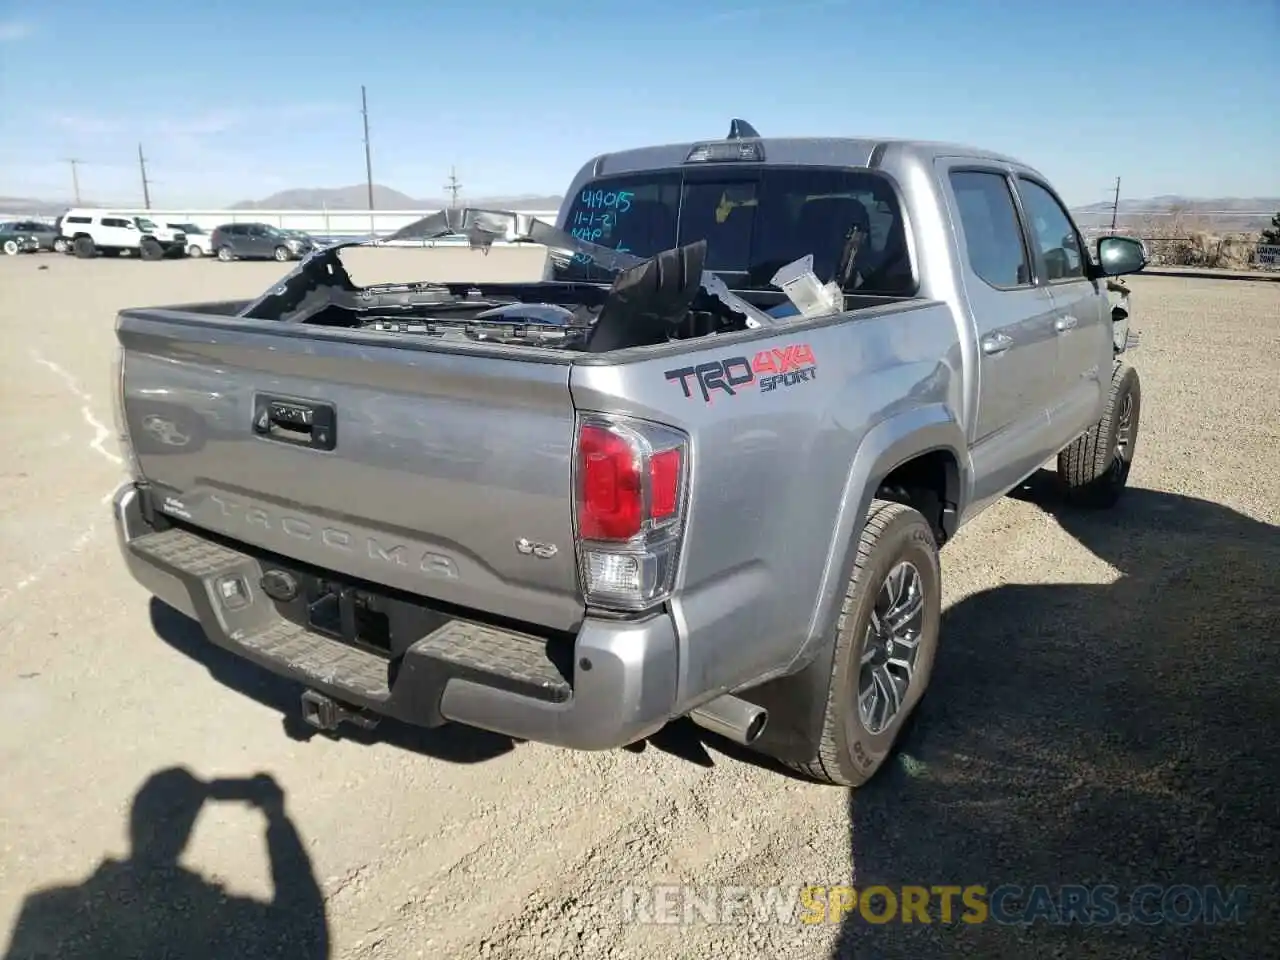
113, 483, 677, 750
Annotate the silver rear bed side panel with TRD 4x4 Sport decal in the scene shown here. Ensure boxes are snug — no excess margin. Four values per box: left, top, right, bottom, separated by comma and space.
570, 301, 966, 710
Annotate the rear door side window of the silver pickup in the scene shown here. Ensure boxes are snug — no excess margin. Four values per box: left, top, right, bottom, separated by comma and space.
950, 170, 1032, 289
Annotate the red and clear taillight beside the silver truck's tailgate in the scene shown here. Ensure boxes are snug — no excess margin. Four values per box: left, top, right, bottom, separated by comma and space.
575, 416, 689, 609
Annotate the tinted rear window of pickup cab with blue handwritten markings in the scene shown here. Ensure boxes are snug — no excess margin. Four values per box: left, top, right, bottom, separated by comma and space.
559, 166, 916, 296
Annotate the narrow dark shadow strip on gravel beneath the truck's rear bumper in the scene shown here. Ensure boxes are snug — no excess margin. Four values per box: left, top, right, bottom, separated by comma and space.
151, 598, 517, 763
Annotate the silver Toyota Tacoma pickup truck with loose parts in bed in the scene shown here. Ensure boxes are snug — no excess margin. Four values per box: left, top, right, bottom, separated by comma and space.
113, 122, 1147, 786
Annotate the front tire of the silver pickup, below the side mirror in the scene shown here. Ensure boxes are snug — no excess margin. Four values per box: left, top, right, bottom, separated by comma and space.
1057, 361, 1142, 509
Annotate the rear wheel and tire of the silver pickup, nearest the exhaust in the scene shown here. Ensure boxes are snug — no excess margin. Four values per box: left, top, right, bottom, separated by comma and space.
788, 499, 942, 787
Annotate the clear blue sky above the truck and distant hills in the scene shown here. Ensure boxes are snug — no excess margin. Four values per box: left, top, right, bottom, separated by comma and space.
0, 0, 1280, 206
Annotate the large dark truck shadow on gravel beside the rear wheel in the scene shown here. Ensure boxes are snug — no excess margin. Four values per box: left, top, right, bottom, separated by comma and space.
833, 471, 1280, 960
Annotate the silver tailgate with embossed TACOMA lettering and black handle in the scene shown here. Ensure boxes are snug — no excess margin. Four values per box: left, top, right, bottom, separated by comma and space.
116, 311, 582, 630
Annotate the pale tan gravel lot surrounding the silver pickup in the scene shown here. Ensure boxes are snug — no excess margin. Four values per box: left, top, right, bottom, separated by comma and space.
0, 251, 1280, 960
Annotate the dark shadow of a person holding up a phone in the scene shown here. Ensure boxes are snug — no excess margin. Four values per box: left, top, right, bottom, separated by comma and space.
5, 768, 329, 960
